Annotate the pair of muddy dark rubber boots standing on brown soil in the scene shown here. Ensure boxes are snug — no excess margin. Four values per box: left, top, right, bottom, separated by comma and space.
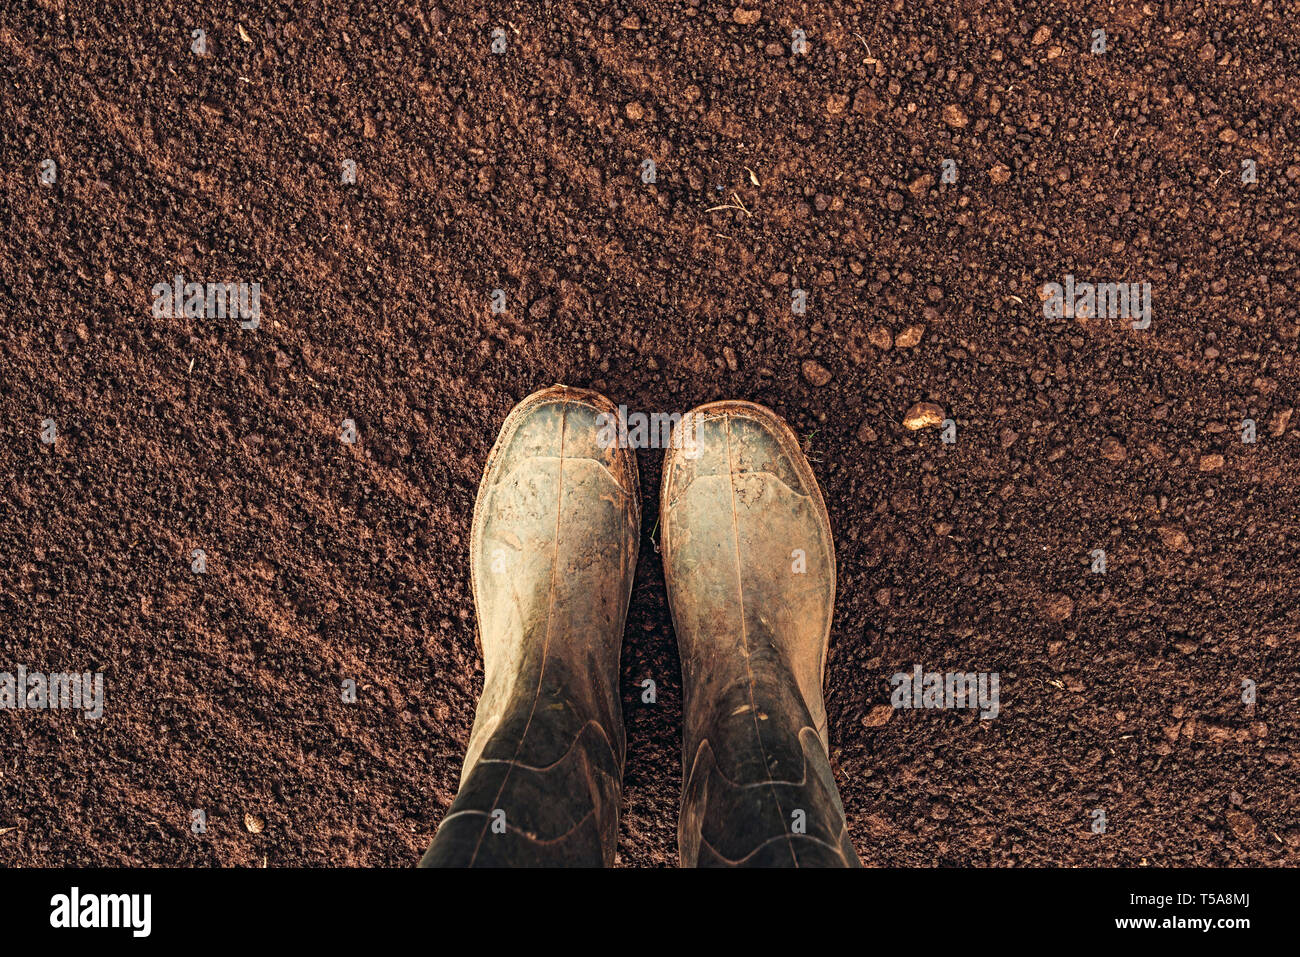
420, 386, 858, 867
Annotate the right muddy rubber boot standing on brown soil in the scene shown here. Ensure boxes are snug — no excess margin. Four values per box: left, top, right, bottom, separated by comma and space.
660, 402, 859, 867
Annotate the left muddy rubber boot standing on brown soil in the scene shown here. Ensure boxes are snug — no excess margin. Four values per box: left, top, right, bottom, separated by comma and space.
420, 386, 641, 867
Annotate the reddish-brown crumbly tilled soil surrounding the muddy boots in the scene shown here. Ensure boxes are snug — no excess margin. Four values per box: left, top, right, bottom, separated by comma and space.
0, 0, 1300, 866
